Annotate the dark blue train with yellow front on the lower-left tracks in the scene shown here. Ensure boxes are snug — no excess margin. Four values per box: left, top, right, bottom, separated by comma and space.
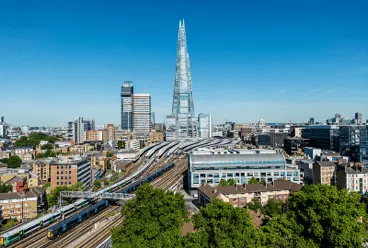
47, 200, 109, 240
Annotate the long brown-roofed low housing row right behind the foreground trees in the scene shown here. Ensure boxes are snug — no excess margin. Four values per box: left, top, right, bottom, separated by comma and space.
198, 179, 302, 207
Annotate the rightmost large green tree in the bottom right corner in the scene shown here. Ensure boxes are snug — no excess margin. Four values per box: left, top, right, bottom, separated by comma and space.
287, 184, 367, 247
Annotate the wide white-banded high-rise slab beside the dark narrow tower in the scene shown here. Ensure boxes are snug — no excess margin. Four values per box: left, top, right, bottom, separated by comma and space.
133, 94, 152, 134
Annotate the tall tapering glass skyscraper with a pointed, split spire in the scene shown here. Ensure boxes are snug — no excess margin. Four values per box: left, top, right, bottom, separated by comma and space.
166, 20, 197, 140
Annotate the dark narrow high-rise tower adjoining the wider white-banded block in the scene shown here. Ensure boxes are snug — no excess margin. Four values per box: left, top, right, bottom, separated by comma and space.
121, 81, 133, 131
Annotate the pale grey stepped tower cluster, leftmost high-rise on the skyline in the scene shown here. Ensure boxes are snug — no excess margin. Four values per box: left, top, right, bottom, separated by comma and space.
68, 117, 95, 144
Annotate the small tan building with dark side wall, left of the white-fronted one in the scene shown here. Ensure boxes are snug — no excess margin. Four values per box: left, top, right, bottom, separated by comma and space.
313, 161, 336, 185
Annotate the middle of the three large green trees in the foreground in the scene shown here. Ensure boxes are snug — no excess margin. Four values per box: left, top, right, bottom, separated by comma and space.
187, 199, 261, 248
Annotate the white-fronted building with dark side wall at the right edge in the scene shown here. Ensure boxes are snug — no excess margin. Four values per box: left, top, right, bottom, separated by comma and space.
336, 163, 368, 194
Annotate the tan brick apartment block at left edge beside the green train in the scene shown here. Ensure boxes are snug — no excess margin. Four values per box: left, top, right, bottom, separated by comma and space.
0, 187, 47, 221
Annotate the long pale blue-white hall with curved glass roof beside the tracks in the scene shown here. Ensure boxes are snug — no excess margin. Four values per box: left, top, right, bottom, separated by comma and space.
188, 149, 301, 194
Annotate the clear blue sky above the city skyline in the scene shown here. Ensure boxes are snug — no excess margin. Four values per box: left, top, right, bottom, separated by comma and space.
0, 0, 368, 126
